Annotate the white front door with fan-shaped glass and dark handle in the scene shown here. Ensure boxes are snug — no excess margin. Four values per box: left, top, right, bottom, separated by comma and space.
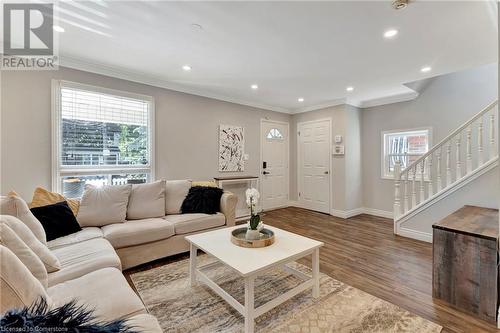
260, 120, 289, 209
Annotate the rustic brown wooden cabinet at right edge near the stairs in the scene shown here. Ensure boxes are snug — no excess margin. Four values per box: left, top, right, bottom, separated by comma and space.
432, 206, 499, 323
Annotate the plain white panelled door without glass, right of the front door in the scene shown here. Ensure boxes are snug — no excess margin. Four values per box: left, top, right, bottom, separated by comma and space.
297, 119, 331, 214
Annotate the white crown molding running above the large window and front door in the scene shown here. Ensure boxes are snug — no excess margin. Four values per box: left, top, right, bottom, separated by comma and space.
59, 55, 292, 114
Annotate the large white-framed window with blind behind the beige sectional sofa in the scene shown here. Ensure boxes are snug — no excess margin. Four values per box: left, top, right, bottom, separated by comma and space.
53, 81, 154, 197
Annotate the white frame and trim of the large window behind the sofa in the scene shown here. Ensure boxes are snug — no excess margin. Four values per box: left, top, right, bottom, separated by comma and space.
51, 80, 156, 193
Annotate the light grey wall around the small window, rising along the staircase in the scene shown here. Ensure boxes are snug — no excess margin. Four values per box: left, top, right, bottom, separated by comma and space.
361, 64, 498, 212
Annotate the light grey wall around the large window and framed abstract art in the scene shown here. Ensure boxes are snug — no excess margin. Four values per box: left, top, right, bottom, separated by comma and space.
0, 68, 290, 199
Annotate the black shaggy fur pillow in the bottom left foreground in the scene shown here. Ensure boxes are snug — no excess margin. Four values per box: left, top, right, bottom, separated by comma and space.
0, 298, 139, 333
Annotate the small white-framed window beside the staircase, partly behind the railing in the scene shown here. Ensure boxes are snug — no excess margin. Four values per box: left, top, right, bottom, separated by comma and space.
382, 128, 431, 178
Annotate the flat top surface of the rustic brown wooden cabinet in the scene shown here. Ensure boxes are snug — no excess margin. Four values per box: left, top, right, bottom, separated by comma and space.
432, 206, 499, 239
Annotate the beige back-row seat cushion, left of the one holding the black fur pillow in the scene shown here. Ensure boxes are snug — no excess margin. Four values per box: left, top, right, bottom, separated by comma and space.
102, 218, 175, 249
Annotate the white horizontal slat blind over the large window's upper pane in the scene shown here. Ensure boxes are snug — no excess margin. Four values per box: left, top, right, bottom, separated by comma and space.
60, 86, 151, 166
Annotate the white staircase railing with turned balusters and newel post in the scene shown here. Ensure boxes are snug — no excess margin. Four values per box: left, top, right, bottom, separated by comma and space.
394, 100, 498, 235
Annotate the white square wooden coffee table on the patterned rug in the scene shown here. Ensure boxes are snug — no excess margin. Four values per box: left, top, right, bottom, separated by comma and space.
186, 226, 323, 333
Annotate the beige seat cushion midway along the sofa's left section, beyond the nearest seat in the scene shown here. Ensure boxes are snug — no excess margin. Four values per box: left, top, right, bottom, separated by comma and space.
49, 238, 121, 286
